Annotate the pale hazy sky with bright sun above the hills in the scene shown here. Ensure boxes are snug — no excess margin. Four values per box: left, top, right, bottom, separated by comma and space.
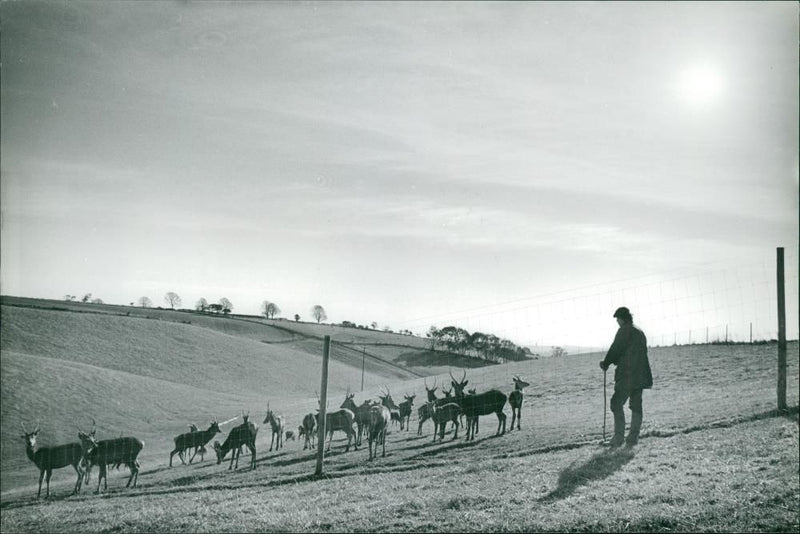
0, 1, 800, 346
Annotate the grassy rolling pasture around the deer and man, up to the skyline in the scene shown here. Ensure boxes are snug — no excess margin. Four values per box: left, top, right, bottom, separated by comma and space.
0, 300, 800, 532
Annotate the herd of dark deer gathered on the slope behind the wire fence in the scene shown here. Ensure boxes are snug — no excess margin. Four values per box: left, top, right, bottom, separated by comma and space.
22, 372, 530, 499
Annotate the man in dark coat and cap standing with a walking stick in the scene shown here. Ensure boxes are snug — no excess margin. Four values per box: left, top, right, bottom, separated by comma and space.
600, 307, 653, 447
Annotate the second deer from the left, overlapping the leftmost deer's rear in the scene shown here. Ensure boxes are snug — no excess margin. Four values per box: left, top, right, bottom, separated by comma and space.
78, 419, 144, 493
